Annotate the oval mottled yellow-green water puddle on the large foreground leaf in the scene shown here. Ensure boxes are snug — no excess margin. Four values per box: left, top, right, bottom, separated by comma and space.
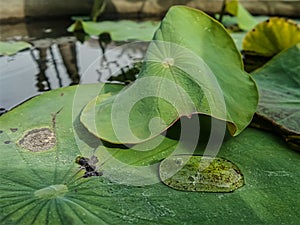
159, 155, 244, 192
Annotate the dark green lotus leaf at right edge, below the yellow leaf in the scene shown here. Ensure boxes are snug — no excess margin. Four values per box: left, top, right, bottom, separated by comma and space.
253, 44, 300, 150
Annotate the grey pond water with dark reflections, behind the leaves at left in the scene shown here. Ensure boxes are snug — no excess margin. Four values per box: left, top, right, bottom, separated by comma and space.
0, 21, 148, 114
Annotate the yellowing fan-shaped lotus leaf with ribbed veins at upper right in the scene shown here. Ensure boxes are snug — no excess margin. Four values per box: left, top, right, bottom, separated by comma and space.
242, 17, 300, 57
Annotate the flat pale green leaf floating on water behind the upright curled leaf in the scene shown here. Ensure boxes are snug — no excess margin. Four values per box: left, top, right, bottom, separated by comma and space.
68, 20, 159, 41
